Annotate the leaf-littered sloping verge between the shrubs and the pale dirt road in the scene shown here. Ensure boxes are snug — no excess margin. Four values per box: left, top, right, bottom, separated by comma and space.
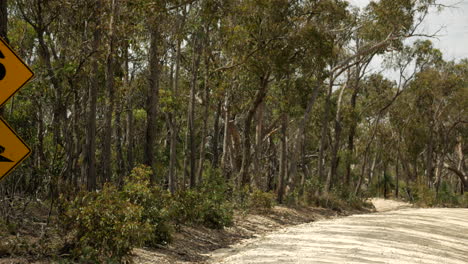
134, 201, 374, 264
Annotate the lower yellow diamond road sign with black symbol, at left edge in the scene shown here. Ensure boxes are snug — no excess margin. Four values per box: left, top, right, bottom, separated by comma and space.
0, 118, 31, 180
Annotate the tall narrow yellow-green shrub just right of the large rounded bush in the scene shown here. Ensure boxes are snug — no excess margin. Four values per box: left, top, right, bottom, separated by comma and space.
123, 165, 172, 246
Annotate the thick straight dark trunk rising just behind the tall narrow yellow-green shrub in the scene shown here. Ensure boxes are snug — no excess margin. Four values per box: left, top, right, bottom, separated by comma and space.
145, 22, 161, 184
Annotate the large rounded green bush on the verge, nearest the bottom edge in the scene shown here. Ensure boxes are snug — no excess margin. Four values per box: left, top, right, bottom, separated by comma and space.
61, 185, 151, 263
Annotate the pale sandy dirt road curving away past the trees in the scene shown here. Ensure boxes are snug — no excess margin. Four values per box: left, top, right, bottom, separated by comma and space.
210, 200, 468, 264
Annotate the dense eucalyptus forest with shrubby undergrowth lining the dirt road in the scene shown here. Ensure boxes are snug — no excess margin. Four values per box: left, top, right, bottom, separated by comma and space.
0, 0, 468, 263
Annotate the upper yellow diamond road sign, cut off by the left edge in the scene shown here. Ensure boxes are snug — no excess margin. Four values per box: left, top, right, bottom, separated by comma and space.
0, 38, 34, 107
